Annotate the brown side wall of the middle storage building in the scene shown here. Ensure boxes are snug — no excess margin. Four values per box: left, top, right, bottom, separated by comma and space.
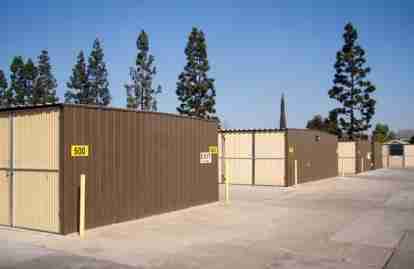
286, 129, 338, 186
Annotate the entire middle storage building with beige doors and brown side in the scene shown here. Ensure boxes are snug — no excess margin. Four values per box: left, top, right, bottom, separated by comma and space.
219, 129, 337, 186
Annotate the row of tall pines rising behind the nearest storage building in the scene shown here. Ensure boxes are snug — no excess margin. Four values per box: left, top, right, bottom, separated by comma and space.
0, 28, 217, 119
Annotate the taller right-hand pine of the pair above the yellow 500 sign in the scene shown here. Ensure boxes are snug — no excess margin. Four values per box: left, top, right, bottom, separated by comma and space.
65, 51, 90, 104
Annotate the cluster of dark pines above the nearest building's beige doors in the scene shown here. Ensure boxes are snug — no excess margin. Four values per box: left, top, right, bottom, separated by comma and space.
0, 50, 58, 107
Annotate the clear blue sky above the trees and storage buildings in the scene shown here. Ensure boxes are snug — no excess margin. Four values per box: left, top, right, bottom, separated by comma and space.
0, 0, 414, 130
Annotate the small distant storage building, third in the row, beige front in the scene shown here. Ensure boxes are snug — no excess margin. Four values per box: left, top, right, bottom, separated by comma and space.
338, 141, 379, 175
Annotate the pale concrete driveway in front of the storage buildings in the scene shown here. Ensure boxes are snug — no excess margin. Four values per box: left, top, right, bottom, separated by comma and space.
0, 170, 414, 269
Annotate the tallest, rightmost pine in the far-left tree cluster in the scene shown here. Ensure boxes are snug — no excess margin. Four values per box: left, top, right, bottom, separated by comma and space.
33, 50, 59, 104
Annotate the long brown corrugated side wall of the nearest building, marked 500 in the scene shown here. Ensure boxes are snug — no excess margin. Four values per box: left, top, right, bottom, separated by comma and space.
61, 106, 218, 234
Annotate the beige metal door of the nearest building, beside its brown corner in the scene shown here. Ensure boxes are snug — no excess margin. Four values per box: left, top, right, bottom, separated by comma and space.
13, 109, 60, 233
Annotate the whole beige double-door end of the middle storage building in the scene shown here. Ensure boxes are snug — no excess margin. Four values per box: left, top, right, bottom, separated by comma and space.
218, 129, 286, 186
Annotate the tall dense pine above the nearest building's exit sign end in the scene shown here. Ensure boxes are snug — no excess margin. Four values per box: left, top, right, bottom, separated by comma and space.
176, 28, 217, 119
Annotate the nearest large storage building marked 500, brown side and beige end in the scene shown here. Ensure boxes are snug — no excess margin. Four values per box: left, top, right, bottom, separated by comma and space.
0, 104, 218, 234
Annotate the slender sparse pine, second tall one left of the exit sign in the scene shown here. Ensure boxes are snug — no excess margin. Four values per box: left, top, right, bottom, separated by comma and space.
125, 31, 161, 111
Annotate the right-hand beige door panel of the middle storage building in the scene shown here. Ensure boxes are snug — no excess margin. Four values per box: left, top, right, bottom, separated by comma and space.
254, 132, 286, 186
